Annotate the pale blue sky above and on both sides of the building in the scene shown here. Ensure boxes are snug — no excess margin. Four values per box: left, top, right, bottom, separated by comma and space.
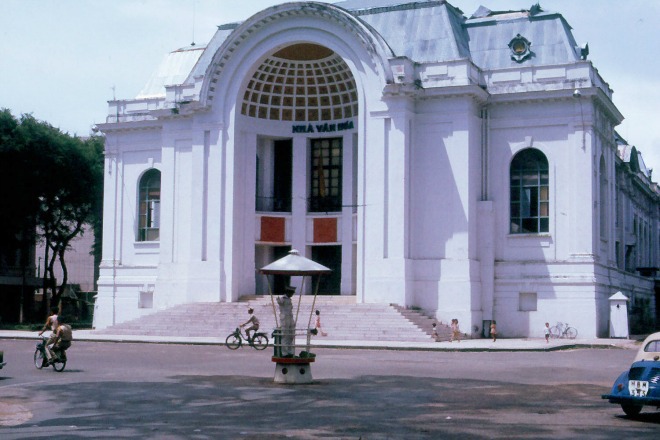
0, 0, 660, 175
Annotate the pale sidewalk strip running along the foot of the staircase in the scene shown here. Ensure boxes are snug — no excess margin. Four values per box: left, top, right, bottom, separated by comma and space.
0, 330, 638, 351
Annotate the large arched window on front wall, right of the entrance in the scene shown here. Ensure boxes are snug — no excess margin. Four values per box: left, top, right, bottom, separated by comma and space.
510, 148, 550, 234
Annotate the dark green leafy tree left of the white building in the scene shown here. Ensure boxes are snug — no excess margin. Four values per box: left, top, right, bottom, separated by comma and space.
0, 109, 103, 316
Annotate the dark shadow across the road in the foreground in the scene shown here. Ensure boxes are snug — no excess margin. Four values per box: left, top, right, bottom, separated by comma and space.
5, 376, 660, 439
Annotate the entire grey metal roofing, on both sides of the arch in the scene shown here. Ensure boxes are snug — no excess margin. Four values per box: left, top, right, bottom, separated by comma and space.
137, 0, 579, 99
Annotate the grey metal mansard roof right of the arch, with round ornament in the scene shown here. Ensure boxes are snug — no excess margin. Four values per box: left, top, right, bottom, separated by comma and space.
342, 0, 579, 70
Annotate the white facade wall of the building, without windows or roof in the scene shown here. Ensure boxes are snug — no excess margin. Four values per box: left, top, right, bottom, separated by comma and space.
95, 0, 658, 337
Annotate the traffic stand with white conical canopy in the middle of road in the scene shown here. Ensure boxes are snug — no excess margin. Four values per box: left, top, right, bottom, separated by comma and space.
260, 249, 332, 384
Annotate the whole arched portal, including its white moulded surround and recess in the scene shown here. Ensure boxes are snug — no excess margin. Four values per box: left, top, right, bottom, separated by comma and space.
195, 3, 392, 301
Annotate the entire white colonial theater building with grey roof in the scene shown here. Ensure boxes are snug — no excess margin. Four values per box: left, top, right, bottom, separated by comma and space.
94, 0, 660, 337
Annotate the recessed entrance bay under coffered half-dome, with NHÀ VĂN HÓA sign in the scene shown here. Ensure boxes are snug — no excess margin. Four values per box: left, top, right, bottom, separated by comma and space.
248, 43, 358, 294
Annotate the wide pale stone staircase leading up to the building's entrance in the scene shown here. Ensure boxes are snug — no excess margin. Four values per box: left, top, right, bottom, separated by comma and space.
98, 295, 449, 342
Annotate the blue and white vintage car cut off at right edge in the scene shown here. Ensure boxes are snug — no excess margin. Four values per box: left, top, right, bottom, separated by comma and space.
602, 332, 660, 417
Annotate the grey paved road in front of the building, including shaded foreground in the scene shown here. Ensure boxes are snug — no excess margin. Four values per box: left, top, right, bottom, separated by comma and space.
0, 340, 660, 440
